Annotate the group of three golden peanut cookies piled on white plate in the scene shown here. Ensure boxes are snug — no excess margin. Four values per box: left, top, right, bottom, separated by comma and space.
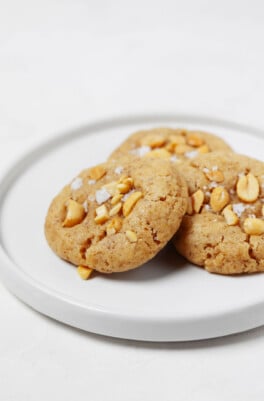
45, 128, 264, 279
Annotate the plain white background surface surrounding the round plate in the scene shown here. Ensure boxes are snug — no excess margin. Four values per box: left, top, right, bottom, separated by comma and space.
0, 0, 264, 401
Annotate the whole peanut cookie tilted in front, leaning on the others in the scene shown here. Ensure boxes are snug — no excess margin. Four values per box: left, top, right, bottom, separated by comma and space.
45, 158, 188, 273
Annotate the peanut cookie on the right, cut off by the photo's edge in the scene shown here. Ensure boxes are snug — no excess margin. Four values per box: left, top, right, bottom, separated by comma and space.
173, 152, 264, 274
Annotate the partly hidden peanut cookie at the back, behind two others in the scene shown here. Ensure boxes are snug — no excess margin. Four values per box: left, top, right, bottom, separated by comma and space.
110, 128, 231, 163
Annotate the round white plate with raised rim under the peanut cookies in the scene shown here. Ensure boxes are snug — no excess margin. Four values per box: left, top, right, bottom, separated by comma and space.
0, 115, 264, 341
